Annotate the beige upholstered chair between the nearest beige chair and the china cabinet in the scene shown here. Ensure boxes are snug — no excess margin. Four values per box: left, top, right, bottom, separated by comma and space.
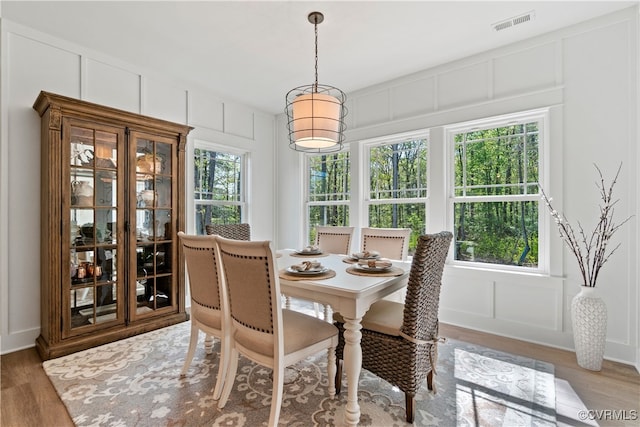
178, 231, 231, 400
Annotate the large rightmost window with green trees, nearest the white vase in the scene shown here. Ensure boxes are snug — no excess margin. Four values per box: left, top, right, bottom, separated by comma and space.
448, 112, 545, 268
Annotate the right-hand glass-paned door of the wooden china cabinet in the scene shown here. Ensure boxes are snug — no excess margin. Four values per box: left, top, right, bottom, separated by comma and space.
129, 132, 177, 319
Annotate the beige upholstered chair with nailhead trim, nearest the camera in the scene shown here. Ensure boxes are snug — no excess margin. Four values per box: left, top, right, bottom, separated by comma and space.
218, 237, 338, 426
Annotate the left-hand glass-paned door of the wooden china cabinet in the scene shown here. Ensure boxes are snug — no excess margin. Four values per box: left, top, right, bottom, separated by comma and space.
62, 120, 125, 336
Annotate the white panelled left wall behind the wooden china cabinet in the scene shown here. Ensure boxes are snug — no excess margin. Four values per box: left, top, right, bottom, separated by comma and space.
0, 19, 275, 353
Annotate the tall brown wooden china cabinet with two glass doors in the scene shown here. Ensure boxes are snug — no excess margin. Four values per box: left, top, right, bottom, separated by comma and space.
33, 92, 192, 359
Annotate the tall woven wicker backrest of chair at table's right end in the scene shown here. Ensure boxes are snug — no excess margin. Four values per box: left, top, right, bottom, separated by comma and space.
401, 231, 453, 340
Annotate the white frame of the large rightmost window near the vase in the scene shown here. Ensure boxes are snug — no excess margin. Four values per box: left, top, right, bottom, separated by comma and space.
443, 108, 550, 274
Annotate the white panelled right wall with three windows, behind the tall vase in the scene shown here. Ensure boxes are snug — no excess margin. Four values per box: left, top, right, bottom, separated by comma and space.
277, 7, 640, 367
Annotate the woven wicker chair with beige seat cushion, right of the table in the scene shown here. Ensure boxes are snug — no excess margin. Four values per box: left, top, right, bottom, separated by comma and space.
334, 231, 453, 423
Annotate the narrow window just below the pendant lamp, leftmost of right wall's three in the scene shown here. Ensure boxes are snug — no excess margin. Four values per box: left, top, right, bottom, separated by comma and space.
307, 151, 351, 244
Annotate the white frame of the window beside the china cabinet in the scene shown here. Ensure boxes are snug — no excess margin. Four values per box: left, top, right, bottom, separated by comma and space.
187, 140, 250, 231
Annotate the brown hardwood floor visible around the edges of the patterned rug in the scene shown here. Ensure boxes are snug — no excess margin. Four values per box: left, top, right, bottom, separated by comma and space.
0, 324, 640, 427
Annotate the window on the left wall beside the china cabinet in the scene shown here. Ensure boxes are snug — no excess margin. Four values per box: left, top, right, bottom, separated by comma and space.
194, 147, 246, 234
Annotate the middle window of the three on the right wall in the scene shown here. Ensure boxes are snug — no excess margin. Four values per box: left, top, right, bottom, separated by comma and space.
365, 132, 427, 254
